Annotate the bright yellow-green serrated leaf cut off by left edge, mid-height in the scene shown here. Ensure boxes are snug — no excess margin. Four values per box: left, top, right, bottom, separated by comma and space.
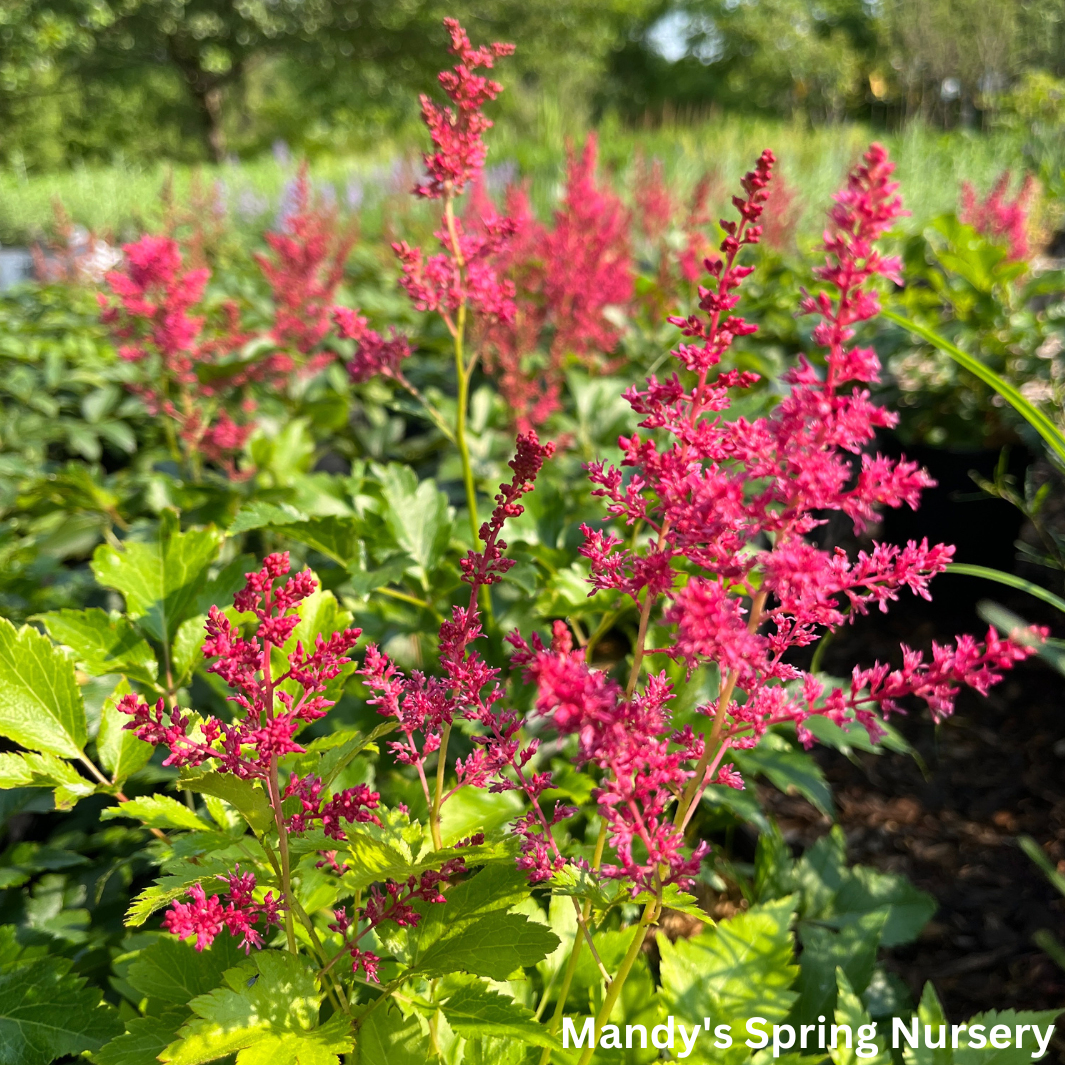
0, 618, 87, 758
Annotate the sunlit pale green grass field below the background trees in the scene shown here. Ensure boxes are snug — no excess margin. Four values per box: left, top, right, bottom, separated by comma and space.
0, 112, 1039, 244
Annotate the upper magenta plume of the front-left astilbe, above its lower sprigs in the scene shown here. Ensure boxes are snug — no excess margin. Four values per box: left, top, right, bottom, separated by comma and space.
118, 552, 361, 779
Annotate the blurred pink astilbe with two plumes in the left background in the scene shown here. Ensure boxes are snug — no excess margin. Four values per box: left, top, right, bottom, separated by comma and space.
98, 167, 354, 479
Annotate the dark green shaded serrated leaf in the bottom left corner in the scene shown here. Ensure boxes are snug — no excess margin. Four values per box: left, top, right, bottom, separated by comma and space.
0, 955, 122, 1065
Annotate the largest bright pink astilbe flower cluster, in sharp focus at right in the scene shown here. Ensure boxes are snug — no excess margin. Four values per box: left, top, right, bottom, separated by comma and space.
513, 145, 1031, 888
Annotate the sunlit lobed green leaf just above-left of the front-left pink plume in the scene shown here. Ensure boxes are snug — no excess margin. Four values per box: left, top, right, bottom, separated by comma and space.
93, 510, 224, 646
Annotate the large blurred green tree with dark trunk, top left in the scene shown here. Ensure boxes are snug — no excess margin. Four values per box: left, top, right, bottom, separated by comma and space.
0, 0, 653, 166
